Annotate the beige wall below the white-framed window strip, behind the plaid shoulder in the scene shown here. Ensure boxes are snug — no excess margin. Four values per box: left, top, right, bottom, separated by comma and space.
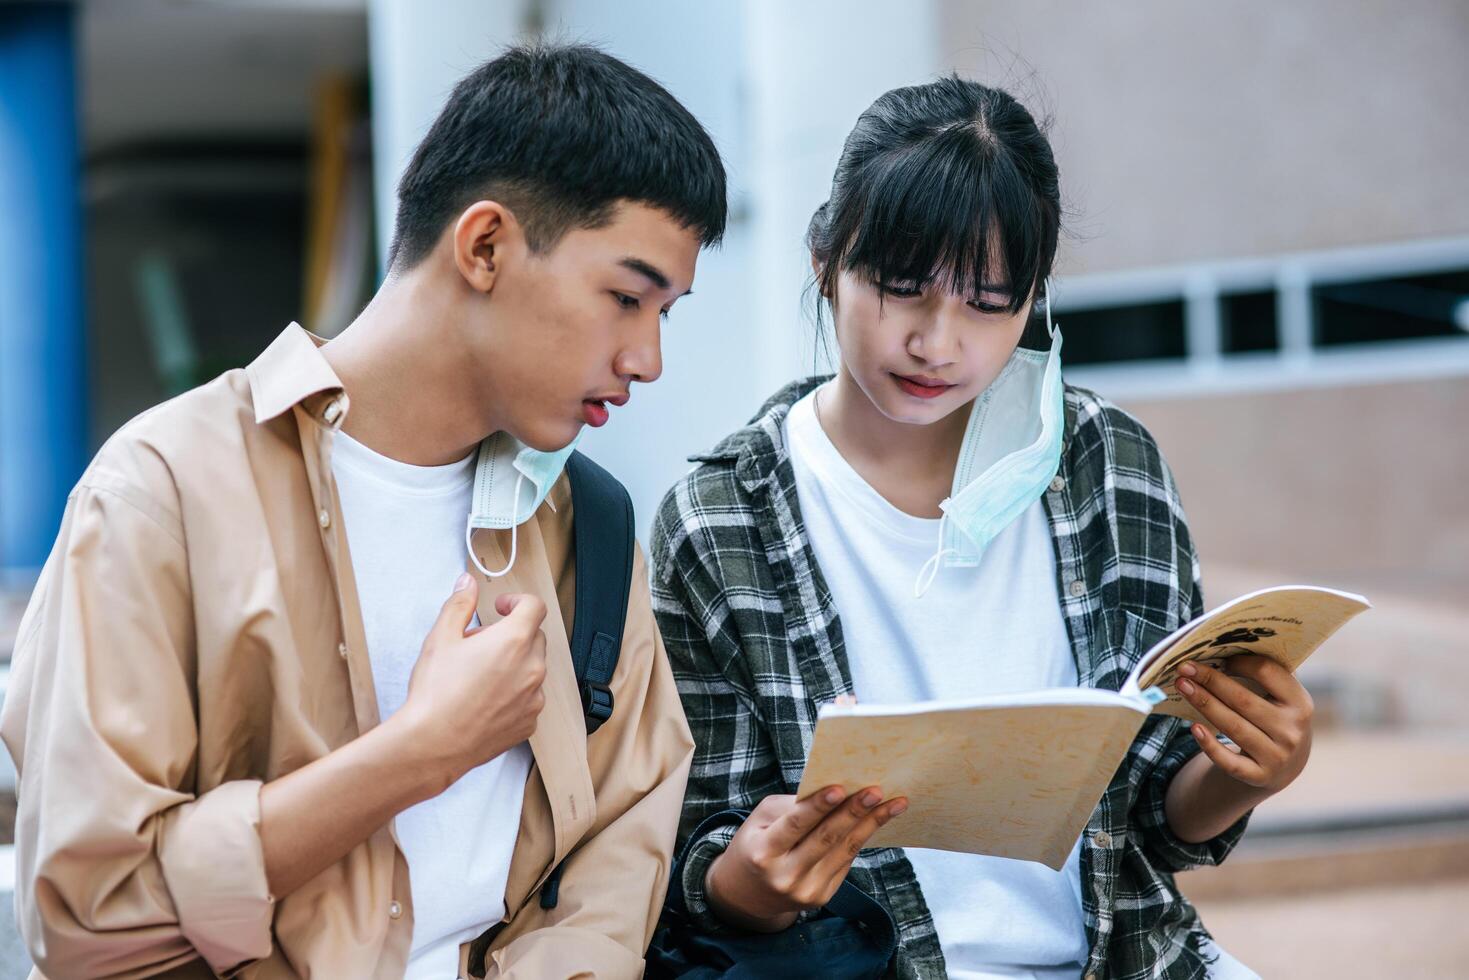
1124, 378, 1469, 608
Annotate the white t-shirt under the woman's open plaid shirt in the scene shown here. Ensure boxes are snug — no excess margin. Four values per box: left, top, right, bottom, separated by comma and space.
786, 395, 1087, 980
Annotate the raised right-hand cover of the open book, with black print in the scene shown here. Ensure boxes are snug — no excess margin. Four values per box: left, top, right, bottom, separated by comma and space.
1130, 585, 1371, 721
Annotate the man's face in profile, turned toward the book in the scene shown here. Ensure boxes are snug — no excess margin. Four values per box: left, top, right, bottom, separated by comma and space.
467, 201, 699, 451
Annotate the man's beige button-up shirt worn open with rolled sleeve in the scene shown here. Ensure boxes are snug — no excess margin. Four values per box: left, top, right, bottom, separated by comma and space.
0, 325, 693, 979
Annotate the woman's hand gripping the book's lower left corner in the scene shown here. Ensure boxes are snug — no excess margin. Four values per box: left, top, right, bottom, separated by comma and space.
704, 786, 908, 933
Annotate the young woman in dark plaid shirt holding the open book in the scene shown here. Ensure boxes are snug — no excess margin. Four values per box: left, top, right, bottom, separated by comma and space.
652, 76, 1310, 979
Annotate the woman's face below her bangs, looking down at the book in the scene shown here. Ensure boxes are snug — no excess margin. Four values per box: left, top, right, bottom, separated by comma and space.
831, 264, 1033, 425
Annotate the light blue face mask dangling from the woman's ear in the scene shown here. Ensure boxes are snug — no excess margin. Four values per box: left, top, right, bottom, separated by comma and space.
914, 279, 1065, 597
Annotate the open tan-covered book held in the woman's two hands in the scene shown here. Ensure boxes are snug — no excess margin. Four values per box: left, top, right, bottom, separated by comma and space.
796, 586, 1369, 870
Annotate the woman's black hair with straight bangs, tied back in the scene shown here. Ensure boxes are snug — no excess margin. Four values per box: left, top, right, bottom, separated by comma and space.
806, 75, 1061, 313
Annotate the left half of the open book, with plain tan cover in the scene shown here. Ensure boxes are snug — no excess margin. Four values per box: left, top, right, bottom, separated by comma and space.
798, 689, 1147, 870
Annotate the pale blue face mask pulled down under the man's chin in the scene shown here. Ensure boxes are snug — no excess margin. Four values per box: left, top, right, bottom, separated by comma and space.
464, 429, 585, 579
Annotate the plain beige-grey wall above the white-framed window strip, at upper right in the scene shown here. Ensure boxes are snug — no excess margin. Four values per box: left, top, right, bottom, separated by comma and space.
940, 0, 1469, 273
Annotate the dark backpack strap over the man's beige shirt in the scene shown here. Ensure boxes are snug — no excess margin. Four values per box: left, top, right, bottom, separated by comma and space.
566, 453, 633, 735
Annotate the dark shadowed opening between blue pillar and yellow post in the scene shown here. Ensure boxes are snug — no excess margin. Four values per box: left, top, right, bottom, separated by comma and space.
87, 145, 308, 442
